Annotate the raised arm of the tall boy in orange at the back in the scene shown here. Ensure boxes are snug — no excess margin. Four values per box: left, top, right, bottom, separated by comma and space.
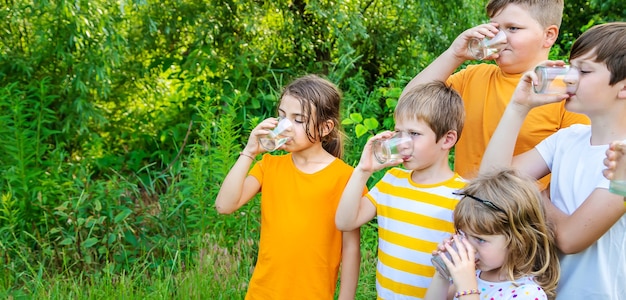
403, 23, 498, 98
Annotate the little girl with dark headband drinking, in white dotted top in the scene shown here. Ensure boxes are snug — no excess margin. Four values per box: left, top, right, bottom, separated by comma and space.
426, 169, 560, 300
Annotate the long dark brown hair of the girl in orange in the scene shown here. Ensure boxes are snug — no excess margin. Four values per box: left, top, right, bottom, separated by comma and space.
279, 75, 344, 158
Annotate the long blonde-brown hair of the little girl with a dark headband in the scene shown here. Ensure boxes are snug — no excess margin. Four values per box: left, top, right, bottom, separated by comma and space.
454, 168, 561, 299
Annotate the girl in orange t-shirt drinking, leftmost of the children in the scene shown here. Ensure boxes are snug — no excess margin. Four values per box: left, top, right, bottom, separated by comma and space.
215, 75, 360, 300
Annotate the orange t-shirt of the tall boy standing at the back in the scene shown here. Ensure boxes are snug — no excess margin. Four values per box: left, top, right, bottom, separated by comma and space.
447, 64, 590, 186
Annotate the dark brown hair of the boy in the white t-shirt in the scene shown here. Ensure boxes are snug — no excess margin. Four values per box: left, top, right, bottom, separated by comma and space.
569, 22, 626, 85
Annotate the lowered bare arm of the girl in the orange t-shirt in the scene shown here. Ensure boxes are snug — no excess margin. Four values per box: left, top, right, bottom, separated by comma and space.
337, 228, 361, 300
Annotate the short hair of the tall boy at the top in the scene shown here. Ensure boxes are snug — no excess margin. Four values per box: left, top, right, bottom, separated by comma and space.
485, 0, 563, 28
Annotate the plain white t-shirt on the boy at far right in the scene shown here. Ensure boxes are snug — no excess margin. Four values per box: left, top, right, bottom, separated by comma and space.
536, 125, 626, 300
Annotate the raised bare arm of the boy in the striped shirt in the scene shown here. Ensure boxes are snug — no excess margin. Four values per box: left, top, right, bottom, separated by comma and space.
335, 131, 401, 231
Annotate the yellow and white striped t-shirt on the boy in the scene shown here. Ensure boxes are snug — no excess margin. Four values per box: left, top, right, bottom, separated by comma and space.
366, 168, 466, 299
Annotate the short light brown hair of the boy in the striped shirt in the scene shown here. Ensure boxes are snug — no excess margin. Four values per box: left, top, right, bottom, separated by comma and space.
394, 81, 465, 141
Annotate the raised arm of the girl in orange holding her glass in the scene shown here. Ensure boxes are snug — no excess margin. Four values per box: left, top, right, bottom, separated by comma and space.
215, 118, 278, 214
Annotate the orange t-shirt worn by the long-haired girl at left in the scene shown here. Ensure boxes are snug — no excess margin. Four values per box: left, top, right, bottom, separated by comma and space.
246, 154, 353, 300
